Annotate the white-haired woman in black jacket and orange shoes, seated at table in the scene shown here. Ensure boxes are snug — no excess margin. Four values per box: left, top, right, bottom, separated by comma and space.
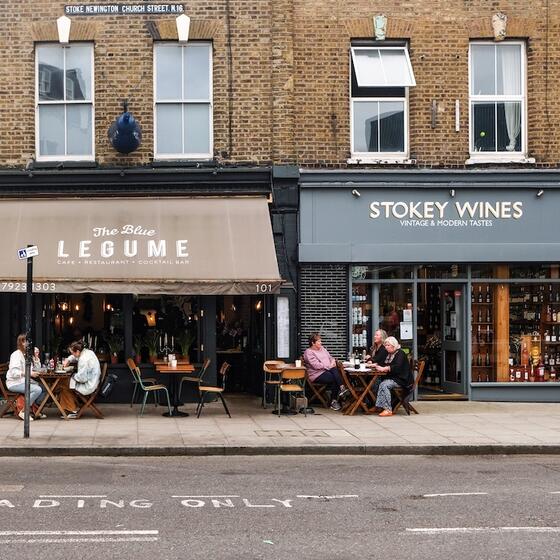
372, 336, 414, 416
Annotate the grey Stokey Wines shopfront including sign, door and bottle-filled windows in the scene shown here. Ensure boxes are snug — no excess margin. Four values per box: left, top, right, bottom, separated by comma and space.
299, 171, 560, 402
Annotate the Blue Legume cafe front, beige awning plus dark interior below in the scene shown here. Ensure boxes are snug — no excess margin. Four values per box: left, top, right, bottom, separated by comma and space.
0, 196, 282, 398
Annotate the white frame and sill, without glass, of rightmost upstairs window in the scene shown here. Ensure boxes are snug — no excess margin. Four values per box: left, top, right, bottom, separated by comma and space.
468, 40, 528, 163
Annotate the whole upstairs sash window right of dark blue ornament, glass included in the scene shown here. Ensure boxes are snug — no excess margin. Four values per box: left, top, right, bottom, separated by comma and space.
154, 42, 212, 159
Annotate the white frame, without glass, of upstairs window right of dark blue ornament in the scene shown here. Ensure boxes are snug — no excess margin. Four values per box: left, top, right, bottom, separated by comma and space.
153, 41, 214, 161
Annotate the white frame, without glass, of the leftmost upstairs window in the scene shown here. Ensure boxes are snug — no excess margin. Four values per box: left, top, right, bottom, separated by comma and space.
34, 41, 95, 162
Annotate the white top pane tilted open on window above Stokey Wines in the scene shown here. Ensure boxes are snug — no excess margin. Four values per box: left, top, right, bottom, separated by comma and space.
351, 47, 416, 87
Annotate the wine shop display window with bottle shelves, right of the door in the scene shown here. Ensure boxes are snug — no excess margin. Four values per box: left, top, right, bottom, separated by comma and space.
471, 280, 560, 383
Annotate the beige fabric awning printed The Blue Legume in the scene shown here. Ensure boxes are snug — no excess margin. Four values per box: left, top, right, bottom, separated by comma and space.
0, 197, 282, 295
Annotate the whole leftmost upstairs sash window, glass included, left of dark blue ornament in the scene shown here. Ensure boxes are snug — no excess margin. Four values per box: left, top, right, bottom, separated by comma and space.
35, 43, 94, 161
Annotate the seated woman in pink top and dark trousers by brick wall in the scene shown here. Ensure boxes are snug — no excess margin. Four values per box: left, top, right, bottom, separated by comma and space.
303, 333, 350, 410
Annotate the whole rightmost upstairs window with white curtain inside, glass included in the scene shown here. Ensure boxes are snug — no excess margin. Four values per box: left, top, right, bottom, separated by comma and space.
469, 42, 527, 158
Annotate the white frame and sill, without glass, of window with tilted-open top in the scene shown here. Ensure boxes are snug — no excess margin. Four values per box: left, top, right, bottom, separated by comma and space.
348, 45, 416, 164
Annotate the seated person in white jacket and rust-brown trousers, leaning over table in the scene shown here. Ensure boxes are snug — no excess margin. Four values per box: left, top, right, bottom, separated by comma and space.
59, 341, 101, 418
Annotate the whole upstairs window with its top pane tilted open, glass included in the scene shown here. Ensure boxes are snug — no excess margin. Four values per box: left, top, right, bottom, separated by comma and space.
350, 45, 416, 161
